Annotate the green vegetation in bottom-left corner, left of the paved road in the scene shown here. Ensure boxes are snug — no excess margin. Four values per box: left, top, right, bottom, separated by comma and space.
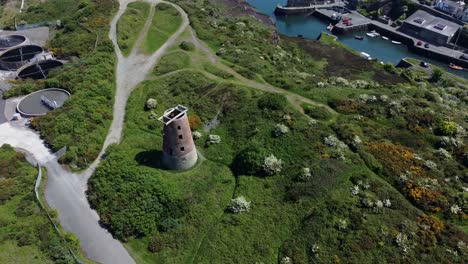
0, 145, 74, 263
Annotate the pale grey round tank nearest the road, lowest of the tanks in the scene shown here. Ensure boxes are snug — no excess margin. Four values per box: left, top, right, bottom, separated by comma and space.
16, 88, 70, 116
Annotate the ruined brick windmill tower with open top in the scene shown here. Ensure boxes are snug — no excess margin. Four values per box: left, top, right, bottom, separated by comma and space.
159, 105, 198, 170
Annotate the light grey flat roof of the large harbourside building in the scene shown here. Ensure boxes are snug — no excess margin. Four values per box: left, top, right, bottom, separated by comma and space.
405, 10, 460, 37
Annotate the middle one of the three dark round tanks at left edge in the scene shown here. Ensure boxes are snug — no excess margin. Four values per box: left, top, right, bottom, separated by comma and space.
0, 45, 44, 70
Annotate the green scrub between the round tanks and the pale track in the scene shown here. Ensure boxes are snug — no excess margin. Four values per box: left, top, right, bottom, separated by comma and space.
5, 0, 116, 168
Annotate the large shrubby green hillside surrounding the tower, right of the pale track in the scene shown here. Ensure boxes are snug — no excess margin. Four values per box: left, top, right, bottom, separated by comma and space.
89, 1, 468, 263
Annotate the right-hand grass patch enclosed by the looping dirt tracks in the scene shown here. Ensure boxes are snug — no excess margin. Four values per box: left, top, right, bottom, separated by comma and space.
142, 3, 182, 53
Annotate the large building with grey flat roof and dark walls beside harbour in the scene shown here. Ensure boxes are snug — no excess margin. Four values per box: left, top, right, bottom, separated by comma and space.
398, 10, 460, 45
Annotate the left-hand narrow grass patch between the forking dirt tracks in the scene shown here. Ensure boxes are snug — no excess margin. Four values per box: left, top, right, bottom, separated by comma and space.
117, 2, 150, 56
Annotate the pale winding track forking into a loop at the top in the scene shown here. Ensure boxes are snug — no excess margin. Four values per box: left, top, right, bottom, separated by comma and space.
0, 0, 189, 264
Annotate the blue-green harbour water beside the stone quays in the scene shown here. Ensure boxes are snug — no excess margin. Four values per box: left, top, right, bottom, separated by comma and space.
247, 0, 468, 79
